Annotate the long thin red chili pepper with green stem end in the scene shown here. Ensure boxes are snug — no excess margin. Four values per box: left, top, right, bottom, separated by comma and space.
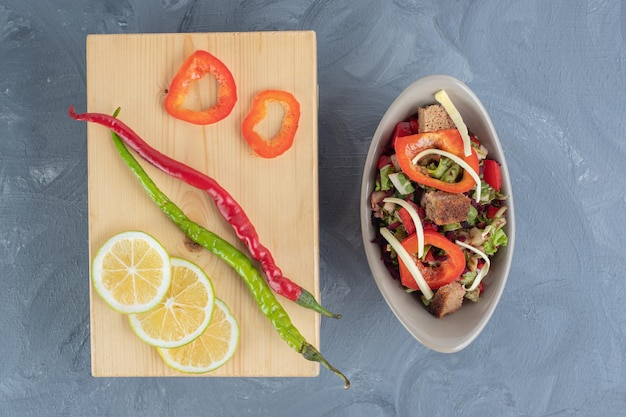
68, 106, 341, 318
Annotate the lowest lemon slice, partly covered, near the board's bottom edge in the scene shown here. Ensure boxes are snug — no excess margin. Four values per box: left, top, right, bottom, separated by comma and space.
157, 299, 239, 374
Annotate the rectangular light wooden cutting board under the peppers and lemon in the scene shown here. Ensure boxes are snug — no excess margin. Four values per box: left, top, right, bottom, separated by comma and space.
86, 31, 323, 377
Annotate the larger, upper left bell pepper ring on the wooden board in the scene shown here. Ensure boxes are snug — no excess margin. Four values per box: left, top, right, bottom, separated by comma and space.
163, 50, 237, 125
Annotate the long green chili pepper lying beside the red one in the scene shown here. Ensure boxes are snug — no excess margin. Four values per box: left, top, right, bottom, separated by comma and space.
111, 132, 350, 389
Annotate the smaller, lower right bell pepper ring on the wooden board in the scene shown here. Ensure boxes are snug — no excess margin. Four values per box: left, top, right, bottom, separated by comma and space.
241, 90, 300, 158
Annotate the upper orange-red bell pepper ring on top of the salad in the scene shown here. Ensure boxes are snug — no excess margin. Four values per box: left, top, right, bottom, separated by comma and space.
394, 129, 478, 194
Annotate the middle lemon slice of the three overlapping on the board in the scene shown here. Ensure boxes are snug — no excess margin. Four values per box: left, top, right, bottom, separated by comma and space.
128, 257, 215, 348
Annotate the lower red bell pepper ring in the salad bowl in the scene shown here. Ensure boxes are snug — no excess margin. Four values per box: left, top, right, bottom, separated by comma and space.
399, 229, 465, 290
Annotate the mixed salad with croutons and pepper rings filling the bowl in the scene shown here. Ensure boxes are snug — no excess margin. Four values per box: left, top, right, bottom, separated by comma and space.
370, 90, 508, 318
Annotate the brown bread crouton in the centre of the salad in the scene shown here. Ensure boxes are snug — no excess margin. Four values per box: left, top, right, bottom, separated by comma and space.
423, 191, 472, 226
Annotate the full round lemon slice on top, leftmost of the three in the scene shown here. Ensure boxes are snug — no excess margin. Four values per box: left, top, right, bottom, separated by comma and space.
91, 231, 171, 314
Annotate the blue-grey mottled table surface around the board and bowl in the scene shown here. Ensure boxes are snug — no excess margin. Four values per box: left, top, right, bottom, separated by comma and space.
0, 0, 626, 417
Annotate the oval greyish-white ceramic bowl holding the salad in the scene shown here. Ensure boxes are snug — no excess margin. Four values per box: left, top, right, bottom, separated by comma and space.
360, 75, 515, 353
